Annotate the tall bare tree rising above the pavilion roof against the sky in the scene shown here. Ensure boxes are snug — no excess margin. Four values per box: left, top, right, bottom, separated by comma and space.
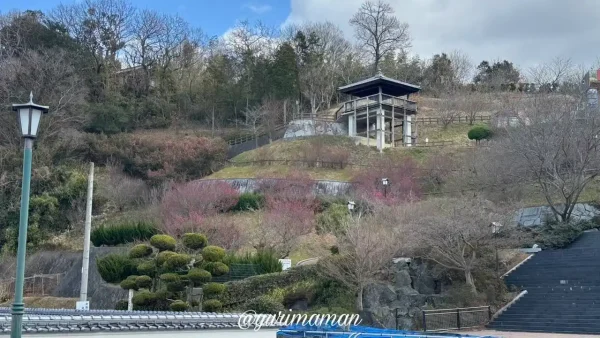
350, 0, 410, 71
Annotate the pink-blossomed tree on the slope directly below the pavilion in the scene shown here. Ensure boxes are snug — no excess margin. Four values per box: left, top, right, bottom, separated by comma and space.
354, 158, 422, 205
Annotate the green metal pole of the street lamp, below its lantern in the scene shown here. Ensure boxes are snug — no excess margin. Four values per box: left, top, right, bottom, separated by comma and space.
10, 138, 33, 338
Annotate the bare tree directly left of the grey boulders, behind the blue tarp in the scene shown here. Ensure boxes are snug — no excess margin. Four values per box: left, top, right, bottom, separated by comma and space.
320, 215, 402, 311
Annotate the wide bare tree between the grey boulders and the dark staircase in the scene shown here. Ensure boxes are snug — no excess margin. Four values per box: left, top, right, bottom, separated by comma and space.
406, 198, 509, 292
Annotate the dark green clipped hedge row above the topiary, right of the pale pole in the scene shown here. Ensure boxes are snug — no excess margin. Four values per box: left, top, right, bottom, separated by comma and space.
90, 221, 158, 246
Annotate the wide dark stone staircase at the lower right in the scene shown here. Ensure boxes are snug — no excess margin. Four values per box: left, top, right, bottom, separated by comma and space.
488, 231, 600, 334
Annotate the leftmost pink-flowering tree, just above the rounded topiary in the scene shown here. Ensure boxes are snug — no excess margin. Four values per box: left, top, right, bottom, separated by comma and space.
161, 180, 239, 236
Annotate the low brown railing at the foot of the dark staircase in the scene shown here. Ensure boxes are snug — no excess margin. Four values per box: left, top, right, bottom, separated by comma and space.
420, 306, 492, 332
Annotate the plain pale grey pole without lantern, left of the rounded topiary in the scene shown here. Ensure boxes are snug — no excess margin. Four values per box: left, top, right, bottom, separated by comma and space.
77, 162, 94, 310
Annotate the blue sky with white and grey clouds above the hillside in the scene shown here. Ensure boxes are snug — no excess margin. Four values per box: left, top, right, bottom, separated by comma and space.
0, 0, 600, 69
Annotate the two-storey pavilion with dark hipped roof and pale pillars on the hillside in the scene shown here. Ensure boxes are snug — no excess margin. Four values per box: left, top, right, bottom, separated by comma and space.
336, 70, 421, 150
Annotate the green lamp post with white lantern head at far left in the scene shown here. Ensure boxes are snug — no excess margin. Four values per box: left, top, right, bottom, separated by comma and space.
10, 93, 48, 338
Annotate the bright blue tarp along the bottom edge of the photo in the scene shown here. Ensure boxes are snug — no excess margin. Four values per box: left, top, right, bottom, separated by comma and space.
277, 325, 496, 338
